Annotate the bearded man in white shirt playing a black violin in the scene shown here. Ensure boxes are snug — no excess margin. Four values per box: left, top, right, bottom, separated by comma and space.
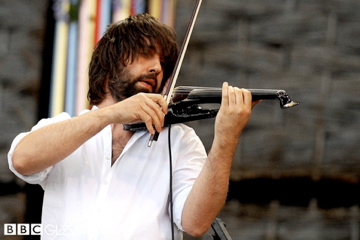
8, 14, 255, 240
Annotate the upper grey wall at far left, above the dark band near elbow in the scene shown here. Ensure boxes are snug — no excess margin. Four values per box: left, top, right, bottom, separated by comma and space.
0, 0, 46, 180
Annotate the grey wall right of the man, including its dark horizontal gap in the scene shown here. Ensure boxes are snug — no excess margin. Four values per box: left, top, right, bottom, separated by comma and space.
177, 0, 360, 240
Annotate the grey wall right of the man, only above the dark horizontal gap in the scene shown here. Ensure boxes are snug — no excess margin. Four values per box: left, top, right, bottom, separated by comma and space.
178, 0, 360, 181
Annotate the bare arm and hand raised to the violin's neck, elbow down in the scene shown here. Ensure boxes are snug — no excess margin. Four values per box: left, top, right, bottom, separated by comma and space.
182, 83, 257, 236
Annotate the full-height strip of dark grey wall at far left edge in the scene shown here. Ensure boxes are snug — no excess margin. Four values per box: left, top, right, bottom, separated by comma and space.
0, 0, 48, 239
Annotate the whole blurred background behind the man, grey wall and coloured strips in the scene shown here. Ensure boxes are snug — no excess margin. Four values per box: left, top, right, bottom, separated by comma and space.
0, 0, 360, 240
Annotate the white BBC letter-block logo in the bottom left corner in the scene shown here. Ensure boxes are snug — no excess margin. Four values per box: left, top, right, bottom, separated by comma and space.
4, 223, 43, 235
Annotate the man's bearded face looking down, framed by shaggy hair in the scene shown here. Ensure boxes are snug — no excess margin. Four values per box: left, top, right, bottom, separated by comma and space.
108, 52, 164, 101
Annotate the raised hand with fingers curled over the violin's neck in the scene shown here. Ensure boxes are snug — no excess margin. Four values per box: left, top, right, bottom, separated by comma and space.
215, 82, 255, 144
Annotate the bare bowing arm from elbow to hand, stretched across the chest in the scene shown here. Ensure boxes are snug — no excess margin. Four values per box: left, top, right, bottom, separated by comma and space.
12, 94, 167, 175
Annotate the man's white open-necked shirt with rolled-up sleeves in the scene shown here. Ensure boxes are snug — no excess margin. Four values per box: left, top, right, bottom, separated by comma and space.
8, 110, 207, 240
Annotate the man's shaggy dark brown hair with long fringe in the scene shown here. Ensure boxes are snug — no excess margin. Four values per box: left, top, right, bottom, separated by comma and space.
88, 13, 179, 105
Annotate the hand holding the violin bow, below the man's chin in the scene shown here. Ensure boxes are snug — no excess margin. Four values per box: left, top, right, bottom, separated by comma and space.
105, 93, 168, 134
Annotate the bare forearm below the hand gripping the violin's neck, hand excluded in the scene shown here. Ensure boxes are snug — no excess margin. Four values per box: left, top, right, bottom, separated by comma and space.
182, 135, 238, 236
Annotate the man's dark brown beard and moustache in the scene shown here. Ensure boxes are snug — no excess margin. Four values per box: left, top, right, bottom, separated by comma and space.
108, 70, 157, 102
